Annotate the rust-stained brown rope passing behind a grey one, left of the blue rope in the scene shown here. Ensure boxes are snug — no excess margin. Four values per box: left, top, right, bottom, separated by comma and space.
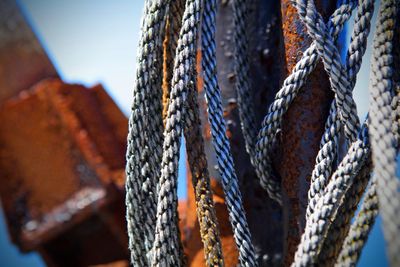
163, 0, 227, 266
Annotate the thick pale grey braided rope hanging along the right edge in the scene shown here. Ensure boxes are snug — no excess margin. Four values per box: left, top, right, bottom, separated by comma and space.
370, 0, 400, 266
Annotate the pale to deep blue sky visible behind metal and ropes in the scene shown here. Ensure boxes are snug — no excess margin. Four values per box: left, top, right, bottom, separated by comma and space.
0, 0, 387, 267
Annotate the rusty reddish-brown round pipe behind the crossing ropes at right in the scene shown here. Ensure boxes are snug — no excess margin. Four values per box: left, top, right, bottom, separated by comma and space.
275, 0, 336, 266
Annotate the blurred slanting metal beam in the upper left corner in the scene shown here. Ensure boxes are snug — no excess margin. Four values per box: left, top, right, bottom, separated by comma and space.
0, 0, 58, 103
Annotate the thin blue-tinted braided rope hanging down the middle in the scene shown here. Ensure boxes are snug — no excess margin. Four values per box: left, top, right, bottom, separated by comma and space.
202, 0, 257, 266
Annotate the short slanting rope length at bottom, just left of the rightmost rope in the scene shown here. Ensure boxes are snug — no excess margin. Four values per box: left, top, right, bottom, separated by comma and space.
335, 181, 378, 267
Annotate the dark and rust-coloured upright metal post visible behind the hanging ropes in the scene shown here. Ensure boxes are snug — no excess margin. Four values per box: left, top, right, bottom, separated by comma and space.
186, 0, 336, 266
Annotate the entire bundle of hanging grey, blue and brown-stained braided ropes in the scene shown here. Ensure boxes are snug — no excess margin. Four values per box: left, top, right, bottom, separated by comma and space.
126, 0, 400, 266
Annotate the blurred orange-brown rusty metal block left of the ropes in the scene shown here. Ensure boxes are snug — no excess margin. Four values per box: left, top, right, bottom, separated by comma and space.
0, 79, 128, 266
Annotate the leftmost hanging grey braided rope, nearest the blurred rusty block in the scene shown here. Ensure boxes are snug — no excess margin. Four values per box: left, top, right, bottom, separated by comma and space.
126, 1, 166, 266
